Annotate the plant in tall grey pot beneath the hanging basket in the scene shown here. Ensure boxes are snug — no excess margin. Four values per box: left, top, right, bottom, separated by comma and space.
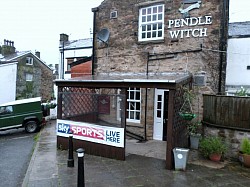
187, 121, 201, 149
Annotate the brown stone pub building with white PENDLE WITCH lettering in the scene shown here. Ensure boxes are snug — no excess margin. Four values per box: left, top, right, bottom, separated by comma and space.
92, 0, 228, 140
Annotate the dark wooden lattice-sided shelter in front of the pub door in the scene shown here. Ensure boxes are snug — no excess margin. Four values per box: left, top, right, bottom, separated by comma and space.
56, 73, 192, 169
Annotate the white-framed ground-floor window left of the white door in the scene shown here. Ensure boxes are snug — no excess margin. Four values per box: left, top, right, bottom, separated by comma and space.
117, 88, 141, 123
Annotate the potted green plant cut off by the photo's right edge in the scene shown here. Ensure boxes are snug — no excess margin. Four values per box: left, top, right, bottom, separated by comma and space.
240, 138, 250, 167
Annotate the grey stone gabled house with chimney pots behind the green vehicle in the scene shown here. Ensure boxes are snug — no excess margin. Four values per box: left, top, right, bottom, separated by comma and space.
0, 40, 53, 101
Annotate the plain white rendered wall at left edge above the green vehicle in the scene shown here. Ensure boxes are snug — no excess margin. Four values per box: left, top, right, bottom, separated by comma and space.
0, 63, 17, 104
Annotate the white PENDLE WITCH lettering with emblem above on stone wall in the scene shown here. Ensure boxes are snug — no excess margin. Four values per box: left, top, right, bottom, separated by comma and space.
168, 0, 213, 39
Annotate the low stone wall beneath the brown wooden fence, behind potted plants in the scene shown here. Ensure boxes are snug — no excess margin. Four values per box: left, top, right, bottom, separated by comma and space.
204, 127, 250, 159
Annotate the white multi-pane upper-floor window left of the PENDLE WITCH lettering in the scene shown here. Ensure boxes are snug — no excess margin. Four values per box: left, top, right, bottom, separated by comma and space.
138, 5, 164, 41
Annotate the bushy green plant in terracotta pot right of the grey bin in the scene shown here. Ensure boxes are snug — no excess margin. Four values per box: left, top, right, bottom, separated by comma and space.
200, 136, 227, 162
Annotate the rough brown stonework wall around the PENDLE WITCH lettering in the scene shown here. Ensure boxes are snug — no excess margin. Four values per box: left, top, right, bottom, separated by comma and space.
94, 0, 225, 138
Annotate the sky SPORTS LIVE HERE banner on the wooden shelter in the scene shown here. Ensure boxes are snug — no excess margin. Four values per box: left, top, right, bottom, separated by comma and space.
56, 120, 124, 147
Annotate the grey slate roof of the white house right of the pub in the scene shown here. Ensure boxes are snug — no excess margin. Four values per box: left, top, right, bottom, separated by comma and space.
228, 21, 250, 37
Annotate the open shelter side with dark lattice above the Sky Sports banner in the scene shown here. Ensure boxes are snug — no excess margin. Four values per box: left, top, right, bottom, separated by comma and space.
59, 87, 125, 126
